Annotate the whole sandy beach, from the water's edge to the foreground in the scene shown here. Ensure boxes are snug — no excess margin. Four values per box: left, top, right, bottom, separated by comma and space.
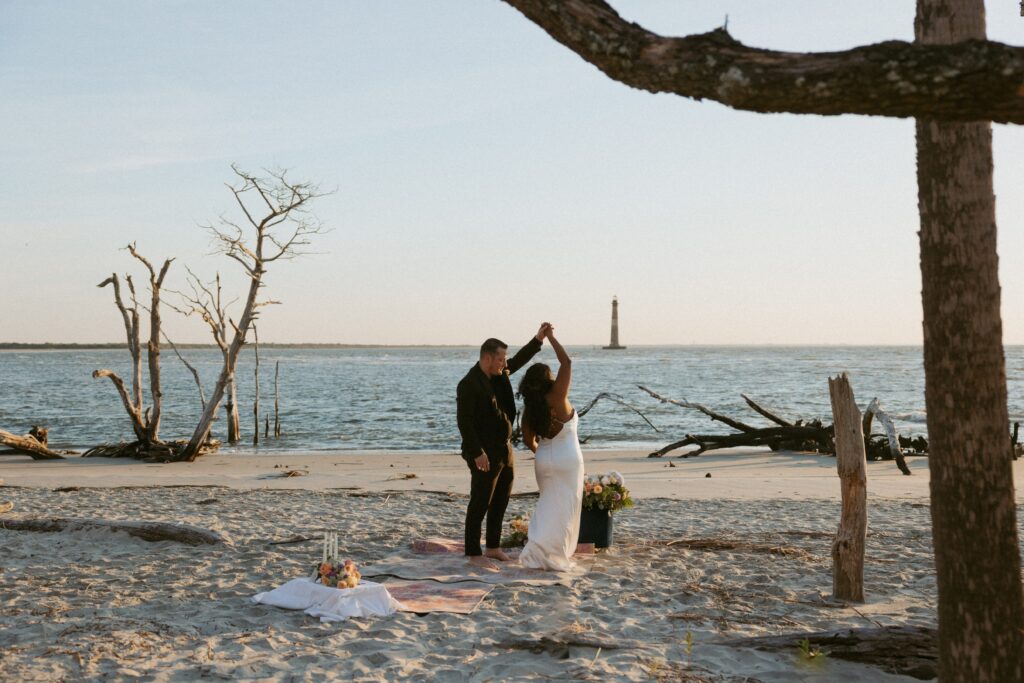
0, 451, 1024, 681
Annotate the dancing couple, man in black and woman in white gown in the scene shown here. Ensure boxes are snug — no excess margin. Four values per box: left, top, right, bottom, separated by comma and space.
457, 323, 584, 571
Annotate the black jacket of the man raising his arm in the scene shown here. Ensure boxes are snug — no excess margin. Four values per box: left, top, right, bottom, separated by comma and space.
456, 337, 541, 462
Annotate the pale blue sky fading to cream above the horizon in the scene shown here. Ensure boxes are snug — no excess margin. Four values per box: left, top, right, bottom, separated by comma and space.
0, 0, 1024, 345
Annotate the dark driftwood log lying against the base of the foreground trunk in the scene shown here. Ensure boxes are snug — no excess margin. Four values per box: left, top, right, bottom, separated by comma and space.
725, 626, 939, 680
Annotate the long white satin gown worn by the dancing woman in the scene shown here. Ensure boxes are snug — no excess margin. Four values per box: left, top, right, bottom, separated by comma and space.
519, 412, 583, 571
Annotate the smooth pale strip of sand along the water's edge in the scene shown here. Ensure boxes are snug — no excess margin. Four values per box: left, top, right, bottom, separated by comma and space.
0, 449, 1024, 503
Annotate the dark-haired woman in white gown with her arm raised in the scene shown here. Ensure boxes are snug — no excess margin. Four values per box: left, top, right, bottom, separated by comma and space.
519, 330, 583, 571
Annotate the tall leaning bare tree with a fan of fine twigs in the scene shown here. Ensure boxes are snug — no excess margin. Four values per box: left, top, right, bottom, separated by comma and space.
179, 166, 324, 461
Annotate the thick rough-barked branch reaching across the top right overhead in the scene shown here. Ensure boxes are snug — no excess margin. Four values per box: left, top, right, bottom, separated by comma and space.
505, 0, 1024, 124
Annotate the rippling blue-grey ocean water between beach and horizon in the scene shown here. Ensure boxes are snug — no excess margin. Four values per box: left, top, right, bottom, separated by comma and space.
0, 346, 1024, 453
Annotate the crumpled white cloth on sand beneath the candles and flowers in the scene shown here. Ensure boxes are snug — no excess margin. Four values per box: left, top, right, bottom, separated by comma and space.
252, 579, 401, 622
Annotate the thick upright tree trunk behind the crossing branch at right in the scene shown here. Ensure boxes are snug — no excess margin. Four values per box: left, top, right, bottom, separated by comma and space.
914, 0, 1024, 681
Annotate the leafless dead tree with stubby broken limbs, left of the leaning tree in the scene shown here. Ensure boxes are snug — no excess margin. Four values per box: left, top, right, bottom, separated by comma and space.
92, 243, 174, 454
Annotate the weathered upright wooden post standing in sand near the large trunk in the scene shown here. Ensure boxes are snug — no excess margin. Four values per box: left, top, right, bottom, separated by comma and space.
828, 373, 867, 602
